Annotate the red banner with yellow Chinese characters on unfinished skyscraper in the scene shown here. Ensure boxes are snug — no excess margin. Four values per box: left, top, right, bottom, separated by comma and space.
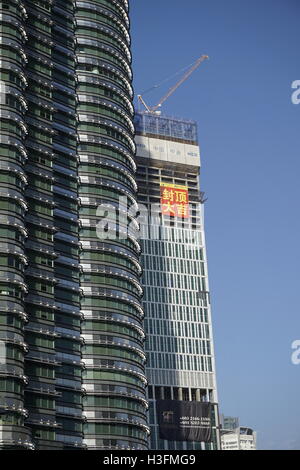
160, 183, 189, 219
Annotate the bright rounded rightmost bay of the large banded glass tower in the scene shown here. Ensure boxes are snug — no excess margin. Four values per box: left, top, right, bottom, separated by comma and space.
76, 0, 148, 449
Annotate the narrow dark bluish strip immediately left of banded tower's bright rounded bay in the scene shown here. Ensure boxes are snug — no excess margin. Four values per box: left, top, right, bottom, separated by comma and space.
52, 0, 83, 449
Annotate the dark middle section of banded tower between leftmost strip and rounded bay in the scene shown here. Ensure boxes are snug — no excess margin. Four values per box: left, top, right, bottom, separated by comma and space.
25, 0, 83, 450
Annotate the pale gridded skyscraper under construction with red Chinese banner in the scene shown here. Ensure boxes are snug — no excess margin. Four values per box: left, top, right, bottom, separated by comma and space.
135, 112, 220, 450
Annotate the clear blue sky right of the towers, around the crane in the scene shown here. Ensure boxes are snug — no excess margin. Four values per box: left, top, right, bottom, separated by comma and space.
131, 0, 300, 449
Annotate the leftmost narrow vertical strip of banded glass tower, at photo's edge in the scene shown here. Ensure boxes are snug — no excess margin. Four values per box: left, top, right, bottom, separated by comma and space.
0, 0, 33, 449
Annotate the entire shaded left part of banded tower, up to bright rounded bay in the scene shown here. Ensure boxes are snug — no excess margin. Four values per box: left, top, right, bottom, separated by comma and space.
0, 1, 83, 449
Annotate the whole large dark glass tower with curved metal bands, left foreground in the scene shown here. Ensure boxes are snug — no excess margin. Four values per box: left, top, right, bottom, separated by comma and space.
0, 0, 148, 449
